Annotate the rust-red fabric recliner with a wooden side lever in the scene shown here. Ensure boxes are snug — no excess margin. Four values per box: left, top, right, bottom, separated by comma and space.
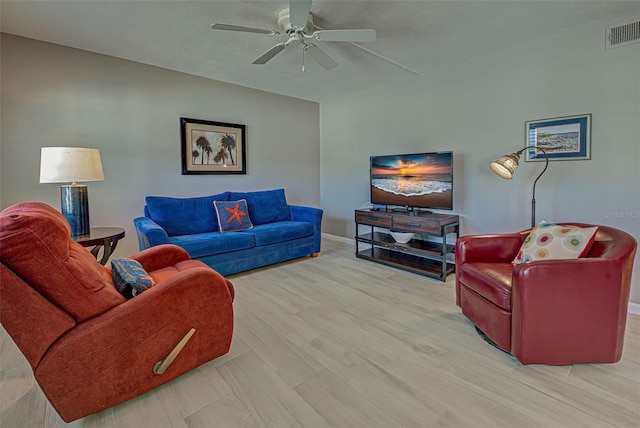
0, 202, 234, 422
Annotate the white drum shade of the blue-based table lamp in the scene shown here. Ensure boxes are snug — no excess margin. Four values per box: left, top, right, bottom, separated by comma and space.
40, 147, 104, 183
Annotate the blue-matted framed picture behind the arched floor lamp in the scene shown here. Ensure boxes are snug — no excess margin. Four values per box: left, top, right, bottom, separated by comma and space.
525, 114, 591, 162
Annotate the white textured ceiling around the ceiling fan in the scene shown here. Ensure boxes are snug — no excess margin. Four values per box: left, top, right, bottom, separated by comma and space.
0, 0, 640, 101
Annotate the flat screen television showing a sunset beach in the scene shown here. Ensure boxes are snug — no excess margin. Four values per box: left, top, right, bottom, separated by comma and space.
370, 152, 453, 211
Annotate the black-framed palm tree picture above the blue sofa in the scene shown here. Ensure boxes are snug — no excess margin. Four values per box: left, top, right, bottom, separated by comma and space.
180, 117, 247, 175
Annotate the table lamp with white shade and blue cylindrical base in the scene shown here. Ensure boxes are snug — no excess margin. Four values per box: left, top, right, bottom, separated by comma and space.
40, 147, 104, 236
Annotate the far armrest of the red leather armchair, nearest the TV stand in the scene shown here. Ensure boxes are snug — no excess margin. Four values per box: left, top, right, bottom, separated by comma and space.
456, 233, 527, 266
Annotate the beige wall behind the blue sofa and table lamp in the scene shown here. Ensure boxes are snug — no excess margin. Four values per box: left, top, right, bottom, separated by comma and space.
0, 34, 320, 256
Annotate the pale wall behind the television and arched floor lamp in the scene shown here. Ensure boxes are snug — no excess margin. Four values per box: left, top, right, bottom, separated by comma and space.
320, 16, 640, 303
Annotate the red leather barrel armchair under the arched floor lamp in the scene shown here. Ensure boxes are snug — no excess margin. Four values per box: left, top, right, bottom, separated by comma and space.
456, 224, 637, 365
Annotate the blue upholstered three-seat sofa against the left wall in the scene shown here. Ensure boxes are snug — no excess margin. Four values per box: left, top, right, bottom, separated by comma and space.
133, 189, 323, 275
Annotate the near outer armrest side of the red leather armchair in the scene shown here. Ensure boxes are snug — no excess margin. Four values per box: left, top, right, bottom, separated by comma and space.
511, 258, 629, 364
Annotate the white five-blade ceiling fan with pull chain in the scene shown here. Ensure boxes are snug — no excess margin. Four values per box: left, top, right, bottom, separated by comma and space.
211, 0, 376, 71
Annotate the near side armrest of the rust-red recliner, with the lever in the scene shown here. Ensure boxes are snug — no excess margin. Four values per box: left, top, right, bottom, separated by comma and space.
35, 267, 233, 421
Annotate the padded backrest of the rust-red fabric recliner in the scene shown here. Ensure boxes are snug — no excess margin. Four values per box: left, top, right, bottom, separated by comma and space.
0, 202, 126, 321
